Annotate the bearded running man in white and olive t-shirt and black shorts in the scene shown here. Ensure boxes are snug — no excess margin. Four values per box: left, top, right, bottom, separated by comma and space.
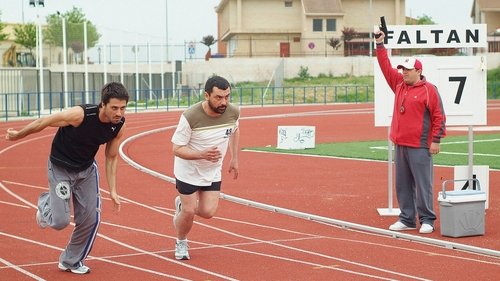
172, 76, 240, 260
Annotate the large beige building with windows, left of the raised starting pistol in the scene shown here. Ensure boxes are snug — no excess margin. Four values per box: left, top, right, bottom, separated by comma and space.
216, 0, 405, 57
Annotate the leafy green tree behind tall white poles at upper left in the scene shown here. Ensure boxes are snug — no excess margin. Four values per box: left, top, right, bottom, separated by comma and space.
44, 7, 101, 63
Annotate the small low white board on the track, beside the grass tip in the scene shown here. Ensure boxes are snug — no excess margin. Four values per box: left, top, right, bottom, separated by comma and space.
277, 126, 316, 149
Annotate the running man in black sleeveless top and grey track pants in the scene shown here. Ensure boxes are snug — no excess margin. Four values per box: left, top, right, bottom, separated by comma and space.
5, 82, 129, 274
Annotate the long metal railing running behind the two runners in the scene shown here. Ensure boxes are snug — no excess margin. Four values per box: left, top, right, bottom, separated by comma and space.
0, 85, 374, 121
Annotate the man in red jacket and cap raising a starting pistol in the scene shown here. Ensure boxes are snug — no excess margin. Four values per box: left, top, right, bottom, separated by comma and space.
375, 31, 446, 233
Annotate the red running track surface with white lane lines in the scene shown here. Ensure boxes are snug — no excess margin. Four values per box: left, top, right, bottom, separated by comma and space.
0, 102, 500, 280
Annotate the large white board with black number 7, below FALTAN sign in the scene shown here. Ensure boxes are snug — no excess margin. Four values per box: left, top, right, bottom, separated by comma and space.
373, 56, 487, 127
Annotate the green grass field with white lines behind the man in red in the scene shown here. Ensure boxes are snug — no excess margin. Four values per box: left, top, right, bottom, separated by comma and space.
247, 134, 500, 169
